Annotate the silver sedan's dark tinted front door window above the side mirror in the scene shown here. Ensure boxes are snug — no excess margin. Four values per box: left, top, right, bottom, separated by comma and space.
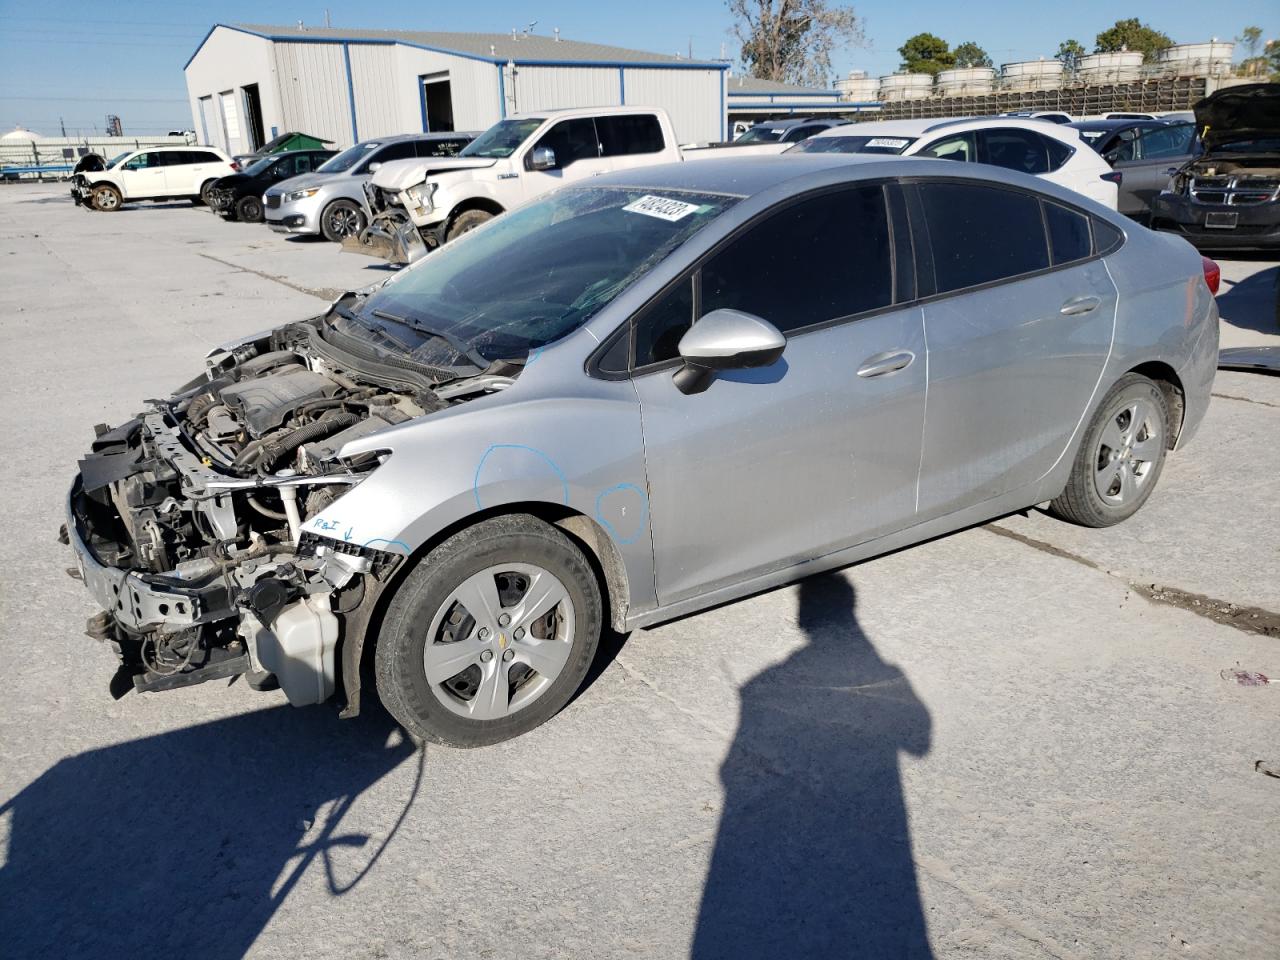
699, 184, 896, 333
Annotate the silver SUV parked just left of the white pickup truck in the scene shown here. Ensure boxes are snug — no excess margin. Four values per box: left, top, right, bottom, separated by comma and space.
262, 132, 476, 243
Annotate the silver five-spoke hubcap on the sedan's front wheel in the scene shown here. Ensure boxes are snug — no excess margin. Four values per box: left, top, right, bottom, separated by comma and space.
422, 563, 573, 719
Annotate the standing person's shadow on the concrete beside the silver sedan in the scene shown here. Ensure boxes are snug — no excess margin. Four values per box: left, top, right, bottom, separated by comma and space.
692, 573, 932, 960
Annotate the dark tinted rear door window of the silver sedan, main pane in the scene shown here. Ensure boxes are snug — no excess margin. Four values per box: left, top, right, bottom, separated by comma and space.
918, 182, 1050, 293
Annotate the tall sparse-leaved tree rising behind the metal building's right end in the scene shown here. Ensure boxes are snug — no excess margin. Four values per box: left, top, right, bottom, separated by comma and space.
726, 0, 865, 86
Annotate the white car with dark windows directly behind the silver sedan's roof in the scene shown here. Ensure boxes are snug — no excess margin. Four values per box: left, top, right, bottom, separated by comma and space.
787, 116, 1121, 210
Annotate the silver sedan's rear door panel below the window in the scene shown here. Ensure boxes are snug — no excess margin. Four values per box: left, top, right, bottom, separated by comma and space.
918, 261, 1116, 521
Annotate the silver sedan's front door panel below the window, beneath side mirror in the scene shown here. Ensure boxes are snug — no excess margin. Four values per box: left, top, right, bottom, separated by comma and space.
635, 307, 925, 604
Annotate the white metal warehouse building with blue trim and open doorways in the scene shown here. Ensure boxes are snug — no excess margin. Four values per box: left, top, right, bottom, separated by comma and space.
184, 24, 727, 154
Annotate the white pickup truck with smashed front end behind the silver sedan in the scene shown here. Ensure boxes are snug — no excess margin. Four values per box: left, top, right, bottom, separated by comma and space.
342, 106, 682, 264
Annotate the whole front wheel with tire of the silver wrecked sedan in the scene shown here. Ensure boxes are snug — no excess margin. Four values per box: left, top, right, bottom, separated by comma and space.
374, 515, 603, 748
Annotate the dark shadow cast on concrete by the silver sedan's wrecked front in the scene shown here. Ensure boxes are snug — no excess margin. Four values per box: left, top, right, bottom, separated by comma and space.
0, 707, 425, 960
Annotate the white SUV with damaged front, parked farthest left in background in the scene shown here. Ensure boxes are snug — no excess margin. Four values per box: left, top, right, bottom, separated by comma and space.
72, 146, 239, 211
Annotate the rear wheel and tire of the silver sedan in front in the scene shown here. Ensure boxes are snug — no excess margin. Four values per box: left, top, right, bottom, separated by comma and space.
1050, 374, 1170, 527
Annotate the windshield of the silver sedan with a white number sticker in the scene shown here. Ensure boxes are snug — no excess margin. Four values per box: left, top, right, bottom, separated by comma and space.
355, 187, 737, 366
